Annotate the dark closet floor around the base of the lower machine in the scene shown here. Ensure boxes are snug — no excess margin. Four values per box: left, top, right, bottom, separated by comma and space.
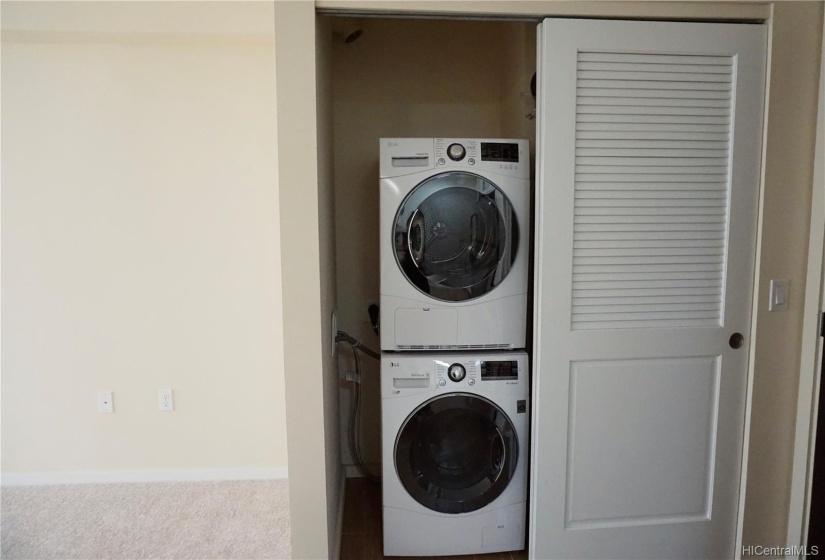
341, 478, 527, 560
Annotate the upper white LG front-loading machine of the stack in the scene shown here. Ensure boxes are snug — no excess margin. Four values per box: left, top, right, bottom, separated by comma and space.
380, 138, 530, 351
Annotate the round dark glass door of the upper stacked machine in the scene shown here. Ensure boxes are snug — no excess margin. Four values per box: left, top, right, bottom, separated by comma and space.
393, 172, 519, 301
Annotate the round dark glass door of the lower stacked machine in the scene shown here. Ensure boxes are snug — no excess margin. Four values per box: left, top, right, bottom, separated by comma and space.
394, 393, 518, 513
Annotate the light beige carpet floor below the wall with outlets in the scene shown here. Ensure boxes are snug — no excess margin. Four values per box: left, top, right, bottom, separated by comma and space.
0, 480, 290, 560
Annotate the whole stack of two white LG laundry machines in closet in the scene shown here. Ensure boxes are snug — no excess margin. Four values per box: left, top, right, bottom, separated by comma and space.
380, 138, 530, 556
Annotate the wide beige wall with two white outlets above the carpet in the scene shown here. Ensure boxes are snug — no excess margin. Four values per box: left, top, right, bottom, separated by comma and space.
2, 1, 290, 477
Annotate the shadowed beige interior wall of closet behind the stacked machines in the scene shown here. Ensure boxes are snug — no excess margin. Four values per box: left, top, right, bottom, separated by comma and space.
325, 16, 536, 470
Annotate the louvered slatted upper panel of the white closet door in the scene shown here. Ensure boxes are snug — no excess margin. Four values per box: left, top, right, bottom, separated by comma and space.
572, 52, 734, 329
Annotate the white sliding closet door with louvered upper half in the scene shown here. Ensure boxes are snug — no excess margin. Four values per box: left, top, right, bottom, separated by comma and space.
530, 19, 767, 560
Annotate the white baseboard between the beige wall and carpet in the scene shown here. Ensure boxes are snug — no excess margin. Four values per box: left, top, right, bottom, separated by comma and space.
0, 467, 288, 486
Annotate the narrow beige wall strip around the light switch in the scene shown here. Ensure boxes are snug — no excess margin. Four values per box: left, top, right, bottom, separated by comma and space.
743, 2, 823, 546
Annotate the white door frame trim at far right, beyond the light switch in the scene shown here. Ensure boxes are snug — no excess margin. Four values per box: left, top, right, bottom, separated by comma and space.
786, 8, 825, 547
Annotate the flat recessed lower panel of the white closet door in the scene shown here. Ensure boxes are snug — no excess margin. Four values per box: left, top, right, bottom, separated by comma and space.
565, 357, 719, 529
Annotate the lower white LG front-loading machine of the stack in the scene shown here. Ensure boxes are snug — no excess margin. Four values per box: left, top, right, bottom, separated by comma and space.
381, 352, 529, 556
